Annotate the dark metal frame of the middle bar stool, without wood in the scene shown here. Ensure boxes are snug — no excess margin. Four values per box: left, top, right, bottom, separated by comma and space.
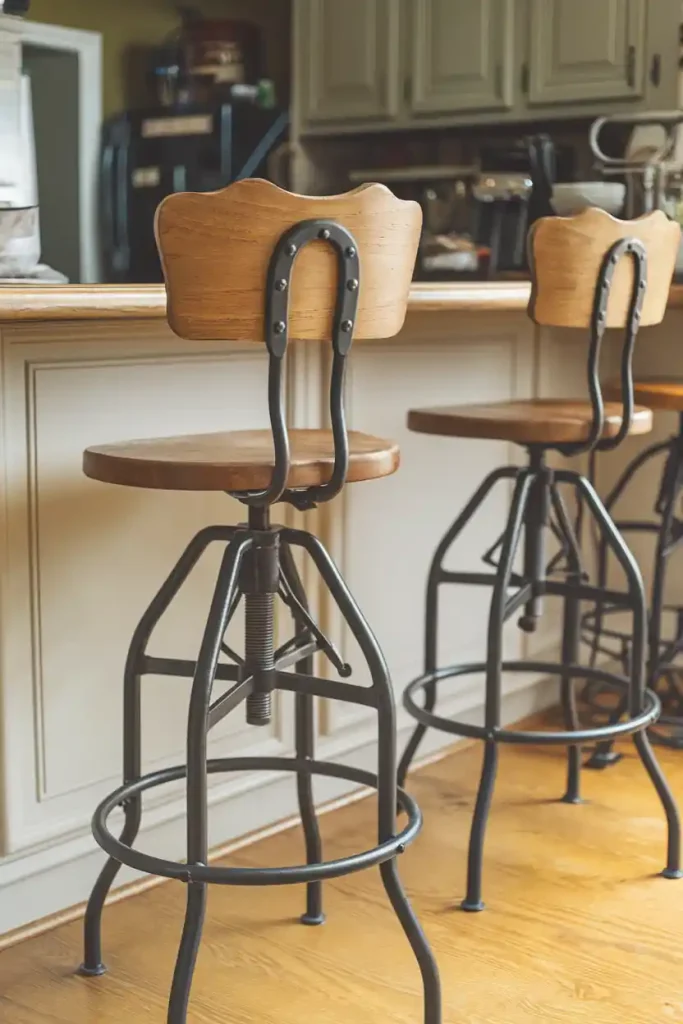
398, 239, 683, 911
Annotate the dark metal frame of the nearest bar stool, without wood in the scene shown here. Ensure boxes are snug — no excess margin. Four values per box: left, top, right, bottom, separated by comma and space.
81, 220, 441, 1024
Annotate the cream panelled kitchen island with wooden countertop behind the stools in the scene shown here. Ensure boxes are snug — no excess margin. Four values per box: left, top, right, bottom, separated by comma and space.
0, 282, 683, 946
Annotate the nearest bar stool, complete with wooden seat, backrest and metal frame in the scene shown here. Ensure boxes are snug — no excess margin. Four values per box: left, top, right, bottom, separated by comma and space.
74, 180, 440, 1024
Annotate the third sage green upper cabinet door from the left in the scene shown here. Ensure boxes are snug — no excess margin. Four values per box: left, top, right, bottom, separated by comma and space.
529, 0, 646, 103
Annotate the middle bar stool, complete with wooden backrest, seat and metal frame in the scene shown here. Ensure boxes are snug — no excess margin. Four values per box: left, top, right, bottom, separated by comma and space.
398, 209, 681, 911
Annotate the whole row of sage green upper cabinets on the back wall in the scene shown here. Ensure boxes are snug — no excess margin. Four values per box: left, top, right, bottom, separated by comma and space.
294, 0, 681, 135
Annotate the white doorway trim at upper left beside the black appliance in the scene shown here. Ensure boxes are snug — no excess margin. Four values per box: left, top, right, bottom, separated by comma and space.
19, 20, 102, 284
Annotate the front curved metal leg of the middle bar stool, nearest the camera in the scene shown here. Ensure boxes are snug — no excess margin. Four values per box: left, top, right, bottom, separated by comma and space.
461, 472, 536, 912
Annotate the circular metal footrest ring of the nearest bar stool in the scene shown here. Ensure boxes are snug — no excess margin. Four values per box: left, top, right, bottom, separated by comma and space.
92, 757, 422, 886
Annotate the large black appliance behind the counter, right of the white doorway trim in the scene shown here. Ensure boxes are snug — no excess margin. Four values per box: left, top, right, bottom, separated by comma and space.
100, 102, 289, 284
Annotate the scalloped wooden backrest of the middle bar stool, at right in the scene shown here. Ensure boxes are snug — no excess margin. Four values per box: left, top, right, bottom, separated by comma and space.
528, 207, 681, 328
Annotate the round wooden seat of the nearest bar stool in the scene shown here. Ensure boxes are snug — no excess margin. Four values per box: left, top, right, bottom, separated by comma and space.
83, 430, 400, 492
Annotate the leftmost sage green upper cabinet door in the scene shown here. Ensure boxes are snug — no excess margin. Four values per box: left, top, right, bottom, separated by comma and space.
296, 0, 399, 123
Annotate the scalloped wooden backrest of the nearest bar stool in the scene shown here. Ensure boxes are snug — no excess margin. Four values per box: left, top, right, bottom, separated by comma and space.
156, 178, 422, 341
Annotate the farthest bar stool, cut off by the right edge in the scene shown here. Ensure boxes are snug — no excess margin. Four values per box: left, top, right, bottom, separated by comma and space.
582, 377, 683, 768
